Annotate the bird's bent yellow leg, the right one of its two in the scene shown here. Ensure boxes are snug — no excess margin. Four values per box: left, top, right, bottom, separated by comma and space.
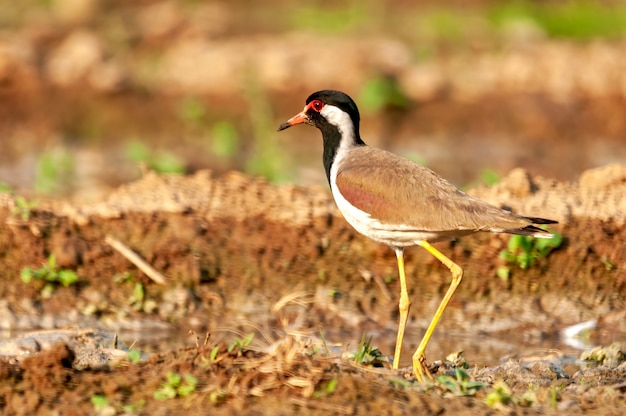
413, 241, 463, 381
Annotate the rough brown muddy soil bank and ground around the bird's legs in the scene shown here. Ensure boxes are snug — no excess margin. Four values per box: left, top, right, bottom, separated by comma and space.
0, 165, 626, 415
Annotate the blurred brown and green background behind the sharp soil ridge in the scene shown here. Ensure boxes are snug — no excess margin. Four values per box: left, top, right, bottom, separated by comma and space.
0, 0, 626, 200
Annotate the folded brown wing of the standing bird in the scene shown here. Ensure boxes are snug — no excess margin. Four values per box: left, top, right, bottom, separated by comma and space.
336, 146, 531, 232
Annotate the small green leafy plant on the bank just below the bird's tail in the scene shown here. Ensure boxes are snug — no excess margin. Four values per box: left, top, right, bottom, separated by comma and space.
496, 233, 563, 280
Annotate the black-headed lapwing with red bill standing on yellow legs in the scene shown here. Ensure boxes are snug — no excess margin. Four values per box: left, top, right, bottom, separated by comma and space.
278, 90, 556, 382
